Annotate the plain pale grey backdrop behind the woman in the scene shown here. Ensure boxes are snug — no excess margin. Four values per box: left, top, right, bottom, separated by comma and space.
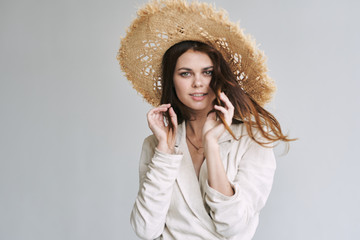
0, 0, 360, 240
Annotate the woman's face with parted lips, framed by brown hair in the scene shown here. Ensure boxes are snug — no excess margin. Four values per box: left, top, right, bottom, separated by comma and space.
173, 50, 215, 114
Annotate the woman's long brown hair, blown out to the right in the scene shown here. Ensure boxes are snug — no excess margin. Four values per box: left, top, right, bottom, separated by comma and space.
160, 41, 294, 146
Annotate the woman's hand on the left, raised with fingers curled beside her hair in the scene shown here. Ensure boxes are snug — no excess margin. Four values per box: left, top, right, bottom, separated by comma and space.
147, 103, 177, 153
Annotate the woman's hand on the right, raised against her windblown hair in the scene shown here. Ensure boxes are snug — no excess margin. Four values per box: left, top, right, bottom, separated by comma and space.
202, 92, 234, 145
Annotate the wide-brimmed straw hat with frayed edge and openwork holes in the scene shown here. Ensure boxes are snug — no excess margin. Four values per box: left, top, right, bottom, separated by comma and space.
117, 0, 275, 106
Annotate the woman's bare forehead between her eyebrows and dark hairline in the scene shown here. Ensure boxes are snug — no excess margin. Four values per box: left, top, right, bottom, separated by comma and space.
176, 49, 213, 69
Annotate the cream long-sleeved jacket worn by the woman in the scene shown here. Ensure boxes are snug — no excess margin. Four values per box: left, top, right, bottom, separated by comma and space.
131, 122, 276, 240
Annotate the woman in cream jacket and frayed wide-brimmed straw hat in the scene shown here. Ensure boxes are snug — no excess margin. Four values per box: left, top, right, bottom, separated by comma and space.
119, 1, 290, 239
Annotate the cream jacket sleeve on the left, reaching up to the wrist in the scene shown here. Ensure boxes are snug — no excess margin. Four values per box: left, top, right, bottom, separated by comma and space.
130, 136, 182, 239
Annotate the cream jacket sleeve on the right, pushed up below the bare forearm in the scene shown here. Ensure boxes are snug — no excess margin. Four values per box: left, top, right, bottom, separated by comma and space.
205, 138, 276, 239
